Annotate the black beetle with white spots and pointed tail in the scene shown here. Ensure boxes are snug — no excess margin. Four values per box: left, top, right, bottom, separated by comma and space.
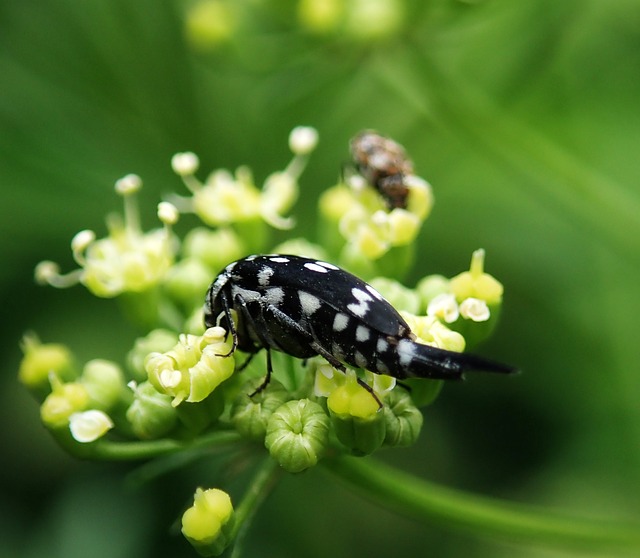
205, 254, 515, 400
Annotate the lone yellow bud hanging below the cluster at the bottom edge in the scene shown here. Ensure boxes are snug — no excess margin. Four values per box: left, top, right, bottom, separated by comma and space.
182, 488, 235, 556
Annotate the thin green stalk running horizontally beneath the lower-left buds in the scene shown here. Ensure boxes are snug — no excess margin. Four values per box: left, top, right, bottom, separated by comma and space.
57, 430, 241, 461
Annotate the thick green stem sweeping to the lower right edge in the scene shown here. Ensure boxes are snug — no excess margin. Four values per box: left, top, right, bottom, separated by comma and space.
323, 457, 640, 553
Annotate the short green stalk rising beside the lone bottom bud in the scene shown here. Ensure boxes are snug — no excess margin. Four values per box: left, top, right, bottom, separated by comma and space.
230, 457, 282, 558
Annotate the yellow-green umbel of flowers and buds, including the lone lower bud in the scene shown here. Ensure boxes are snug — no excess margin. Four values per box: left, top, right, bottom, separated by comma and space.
19, 127, 502, 555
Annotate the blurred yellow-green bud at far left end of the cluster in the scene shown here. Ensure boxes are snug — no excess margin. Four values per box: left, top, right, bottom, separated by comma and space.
18, 334, 76, 397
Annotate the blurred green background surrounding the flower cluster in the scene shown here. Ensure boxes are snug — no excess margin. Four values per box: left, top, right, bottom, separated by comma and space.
0, 0, 640, 558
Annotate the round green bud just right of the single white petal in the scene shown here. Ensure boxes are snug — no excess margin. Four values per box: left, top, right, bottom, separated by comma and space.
126, 382, 178, 440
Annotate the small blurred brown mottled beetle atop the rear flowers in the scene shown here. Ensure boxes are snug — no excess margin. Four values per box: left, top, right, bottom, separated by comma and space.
350, 130, 413, 209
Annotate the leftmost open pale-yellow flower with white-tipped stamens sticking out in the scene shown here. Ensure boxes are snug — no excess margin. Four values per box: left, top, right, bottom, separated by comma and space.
35, 174, 178, 297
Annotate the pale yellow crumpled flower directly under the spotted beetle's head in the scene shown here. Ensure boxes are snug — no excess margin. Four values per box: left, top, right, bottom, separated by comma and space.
145, 327, 235, 406
